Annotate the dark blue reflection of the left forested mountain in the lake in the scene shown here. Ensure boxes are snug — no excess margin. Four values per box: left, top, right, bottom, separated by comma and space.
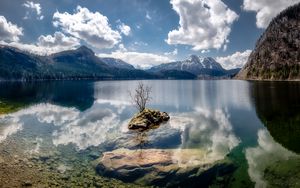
0, 81, 94, 113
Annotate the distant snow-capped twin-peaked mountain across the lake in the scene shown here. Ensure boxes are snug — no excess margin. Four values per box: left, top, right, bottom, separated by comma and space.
149, 55, 239, 78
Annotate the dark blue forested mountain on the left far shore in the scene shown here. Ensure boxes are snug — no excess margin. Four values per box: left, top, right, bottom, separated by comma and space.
0, 45, 155, 80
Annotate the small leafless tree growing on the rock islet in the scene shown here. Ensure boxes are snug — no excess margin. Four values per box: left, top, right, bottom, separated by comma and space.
129, 82, 151, 112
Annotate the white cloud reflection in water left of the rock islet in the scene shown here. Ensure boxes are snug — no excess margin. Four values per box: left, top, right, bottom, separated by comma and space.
0, 101, 124, 149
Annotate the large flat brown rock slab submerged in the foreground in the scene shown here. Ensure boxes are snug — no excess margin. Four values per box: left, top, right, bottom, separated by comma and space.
95, 149, 235, 187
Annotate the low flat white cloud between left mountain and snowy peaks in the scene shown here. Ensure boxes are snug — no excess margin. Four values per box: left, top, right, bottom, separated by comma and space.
98, 51, 173, 69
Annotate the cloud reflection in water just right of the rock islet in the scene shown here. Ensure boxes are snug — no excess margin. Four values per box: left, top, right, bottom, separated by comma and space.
170, 108, 240, 165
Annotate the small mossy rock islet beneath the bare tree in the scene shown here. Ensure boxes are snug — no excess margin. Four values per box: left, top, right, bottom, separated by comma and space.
128, 109, 170, 130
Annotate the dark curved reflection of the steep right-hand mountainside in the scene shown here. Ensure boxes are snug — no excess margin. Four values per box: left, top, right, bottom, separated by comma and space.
252, 82, 300, 153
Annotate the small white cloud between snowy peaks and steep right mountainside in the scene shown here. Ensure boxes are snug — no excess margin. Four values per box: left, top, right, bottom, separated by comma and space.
216, 50, 252, 69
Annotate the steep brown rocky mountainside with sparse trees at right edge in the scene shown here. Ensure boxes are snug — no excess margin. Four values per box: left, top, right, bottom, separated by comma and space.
236, 3, 300, 80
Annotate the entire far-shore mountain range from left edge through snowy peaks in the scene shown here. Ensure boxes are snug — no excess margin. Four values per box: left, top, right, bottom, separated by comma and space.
0, 45, 237, 81
